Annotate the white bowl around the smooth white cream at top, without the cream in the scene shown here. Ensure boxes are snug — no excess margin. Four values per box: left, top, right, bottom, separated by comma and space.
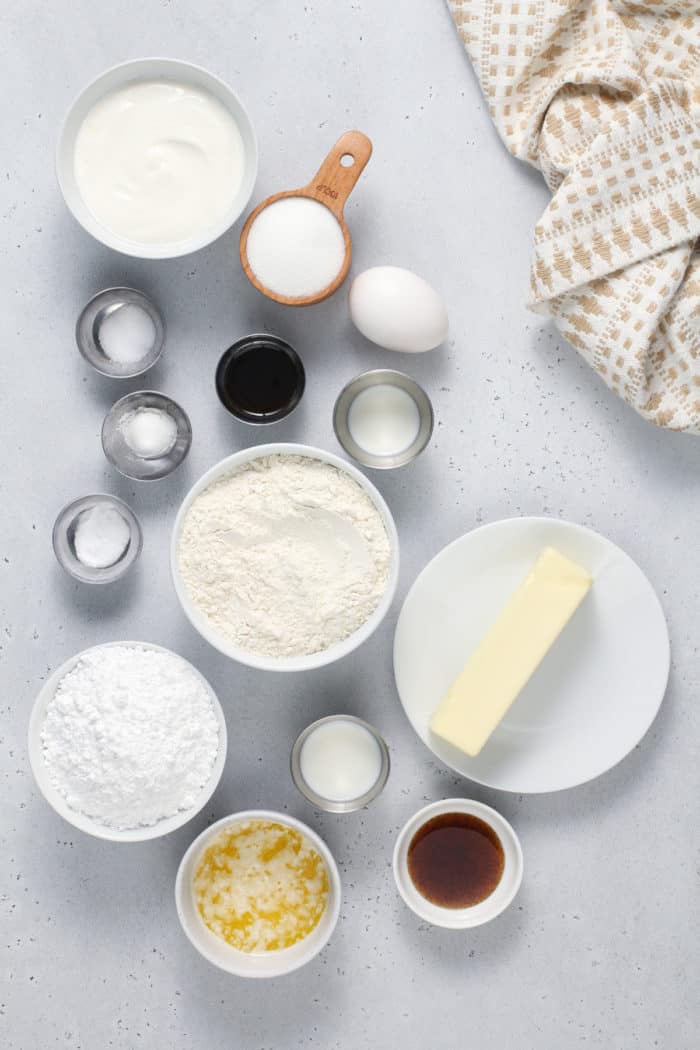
56, 58, 257, 259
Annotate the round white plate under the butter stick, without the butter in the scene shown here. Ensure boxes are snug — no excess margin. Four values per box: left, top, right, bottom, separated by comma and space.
394, 518, 670, 793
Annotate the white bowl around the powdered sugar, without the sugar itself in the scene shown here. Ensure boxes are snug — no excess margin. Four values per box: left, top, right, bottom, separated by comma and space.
28, 642, 227, 842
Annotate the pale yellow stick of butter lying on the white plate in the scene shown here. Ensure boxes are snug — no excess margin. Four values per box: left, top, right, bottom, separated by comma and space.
430, 547, 593, 755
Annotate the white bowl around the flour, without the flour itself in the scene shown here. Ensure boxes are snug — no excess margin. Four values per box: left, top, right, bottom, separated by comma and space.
170, 442, 399, 671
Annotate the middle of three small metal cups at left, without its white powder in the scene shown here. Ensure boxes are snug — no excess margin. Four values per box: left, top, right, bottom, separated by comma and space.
102, 391, 192, 481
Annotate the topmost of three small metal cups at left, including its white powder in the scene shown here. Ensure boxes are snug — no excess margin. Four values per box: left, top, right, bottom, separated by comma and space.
76, 288, 165, 379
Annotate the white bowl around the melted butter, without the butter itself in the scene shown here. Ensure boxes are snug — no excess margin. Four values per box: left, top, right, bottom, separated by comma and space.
175, 810, 341, 978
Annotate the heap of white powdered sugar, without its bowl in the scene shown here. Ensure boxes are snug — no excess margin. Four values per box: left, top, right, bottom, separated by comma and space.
41, 646, 219, 830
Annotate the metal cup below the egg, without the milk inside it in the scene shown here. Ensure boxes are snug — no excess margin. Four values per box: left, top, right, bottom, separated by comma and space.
333, 369, 434, 470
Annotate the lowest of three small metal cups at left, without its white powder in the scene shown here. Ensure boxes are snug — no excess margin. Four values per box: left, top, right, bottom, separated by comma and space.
51, 492, 144, 584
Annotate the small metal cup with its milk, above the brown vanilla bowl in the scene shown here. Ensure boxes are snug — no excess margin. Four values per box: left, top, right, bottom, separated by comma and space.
291, 715, 390, 813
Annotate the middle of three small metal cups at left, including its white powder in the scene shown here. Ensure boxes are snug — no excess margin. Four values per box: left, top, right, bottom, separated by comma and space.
102, 391, 192, 481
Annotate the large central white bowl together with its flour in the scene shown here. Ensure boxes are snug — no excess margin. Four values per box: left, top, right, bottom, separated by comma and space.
171, 443, 399, 671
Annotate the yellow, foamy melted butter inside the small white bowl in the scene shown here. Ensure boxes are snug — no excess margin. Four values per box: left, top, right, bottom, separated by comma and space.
193, 820, 328, 953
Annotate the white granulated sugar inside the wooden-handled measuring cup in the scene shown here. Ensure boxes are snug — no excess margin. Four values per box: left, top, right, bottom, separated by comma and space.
246, 196, 345, 298
